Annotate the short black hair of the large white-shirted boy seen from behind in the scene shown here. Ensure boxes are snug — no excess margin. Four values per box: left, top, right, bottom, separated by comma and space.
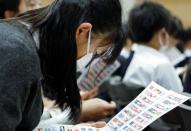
128, 2, 170, 43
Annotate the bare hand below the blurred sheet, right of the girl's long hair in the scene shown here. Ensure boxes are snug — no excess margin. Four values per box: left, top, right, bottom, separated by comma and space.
80, 98, 116, 121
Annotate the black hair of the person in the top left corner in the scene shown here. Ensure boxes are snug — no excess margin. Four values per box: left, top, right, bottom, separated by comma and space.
0, 0, 20, 18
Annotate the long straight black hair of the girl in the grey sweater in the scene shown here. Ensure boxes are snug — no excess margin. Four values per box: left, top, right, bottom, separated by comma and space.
13, 0, 122, 119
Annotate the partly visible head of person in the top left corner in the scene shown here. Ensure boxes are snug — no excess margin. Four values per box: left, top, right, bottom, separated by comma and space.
0, 0, 27, 19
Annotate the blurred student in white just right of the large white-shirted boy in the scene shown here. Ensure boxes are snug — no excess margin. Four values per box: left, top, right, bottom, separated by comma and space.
160, 16, 189, 80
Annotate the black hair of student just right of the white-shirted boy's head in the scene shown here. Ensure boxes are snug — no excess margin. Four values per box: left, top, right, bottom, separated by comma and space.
167, 16, 184, 40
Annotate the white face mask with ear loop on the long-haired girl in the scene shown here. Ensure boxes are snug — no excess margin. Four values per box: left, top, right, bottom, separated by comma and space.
77, 30, 93, 71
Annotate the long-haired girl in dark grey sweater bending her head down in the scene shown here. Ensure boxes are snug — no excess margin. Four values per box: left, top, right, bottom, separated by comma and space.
0, 0, 122, 131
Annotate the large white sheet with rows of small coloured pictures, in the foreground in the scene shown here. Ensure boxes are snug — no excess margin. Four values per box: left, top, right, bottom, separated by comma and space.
35, 82, 190, 131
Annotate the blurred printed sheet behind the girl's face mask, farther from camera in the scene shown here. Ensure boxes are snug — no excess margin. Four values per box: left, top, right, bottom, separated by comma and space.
77, 59, 120, 91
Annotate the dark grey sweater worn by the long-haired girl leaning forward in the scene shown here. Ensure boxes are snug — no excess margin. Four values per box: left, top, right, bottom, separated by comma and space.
0, 21, 43, 131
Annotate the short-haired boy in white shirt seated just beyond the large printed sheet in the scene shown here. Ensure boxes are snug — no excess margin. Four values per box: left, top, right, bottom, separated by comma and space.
123, 2, 183, 92
